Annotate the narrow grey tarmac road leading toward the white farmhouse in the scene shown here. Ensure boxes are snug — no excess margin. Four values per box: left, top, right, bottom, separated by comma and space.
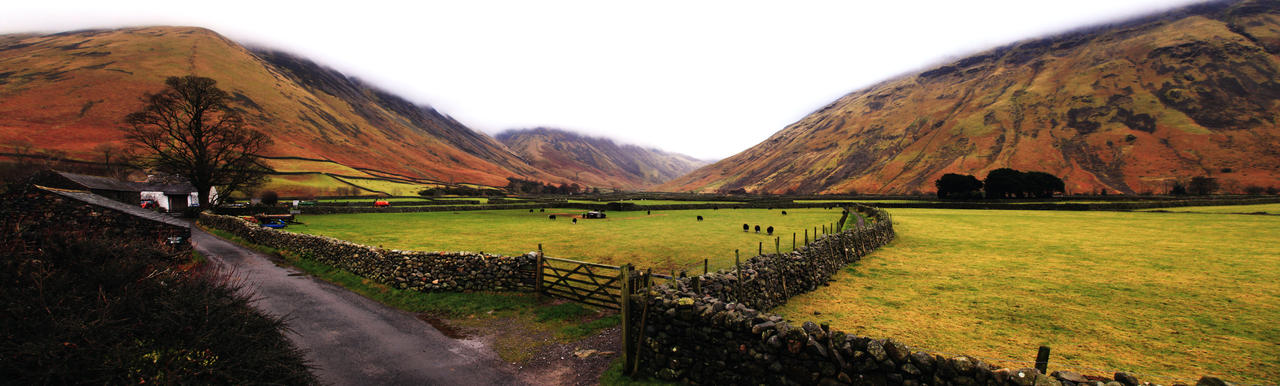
191, 228, 517, 385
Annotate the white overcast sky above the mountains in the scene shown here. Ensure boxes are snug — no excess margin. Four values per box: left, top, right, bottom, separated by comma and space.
0, 0, 1199, 158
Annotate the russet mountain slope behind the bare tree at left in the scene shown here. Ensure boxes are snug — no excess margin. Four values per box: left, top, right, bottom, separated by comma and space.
0, 27, 559, 194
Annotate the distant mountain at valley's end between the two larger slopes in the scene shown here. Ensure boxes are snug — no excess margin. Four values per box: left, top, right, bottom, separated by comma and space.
497, 128, 708, 190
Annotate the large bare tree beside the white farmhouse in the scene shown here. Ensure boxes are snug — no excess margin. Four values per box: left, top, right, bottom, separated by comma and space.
123, 75, 271, 208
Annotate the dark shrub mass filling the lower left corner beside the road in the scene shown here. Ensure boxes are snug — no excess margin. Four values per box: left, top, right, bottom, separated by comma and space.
0, 238, 316, 385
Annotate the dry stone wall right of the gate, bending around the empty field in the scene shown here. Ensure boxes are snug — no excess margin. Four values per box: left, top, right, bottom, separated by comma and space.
627, 207, 1225, 386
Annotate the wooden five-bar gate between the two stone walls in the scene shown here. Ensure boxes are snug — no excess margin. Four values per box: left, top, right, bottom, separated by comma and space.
536, 253, 625, 309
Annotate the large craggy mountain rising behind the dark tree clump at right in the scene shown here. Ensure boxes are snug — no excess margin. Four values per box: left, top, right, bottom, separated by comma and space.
657, 1, 1280, 193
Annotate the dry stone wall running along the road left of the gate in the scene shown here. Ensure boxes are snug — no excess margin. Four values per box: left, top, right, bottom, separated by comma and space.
198, 213, 538, 291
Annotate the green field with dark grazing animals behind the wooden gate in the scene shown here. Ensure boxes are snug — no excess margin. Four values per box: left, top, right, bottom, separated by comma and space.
288, 208, 840, 274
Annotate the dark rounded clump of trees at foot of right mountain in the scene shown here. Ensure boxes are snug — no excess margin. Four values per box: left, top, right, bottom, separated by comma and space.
933, 167, 1066, 198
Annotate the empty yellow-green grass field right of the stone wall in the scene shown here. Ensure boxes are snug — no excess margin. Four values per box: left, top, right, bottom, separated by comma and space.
774, 207, 1280, 385
